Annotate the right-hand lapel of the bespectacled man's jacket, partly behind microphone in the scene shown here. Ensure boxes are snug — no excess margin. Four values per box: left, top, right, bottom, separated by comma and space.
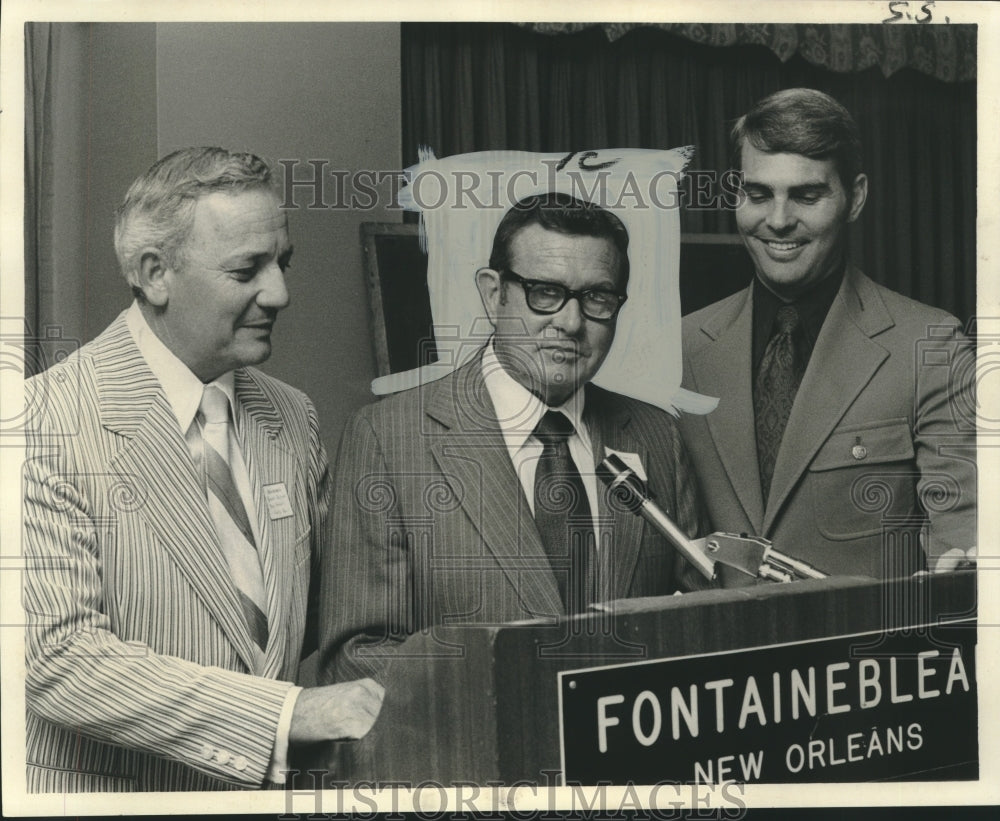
583, 385, 655, 599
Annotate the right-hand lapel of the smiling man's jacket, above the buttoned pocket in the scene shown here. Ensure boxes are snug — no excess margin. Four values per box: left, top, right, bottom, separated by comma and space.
760, 269, 893, 534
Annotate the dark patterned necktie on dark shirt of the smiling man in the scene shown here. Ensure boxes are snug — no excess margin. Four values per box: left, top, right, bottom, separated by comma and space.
753, 305, 802, 505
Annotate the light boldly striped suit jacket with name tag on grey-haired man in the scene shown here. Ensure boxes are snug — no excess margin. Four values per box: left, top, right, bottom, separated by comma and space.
24, 314, 330, 792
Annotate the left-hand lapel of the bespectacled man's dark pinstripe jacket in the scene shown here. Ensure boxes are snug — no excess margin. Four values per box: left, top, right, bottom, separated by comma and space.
425, 357, 565, 617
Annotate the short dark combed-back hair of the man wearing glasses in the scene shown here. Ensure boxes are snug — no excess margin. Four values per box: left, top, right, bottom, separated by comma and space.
490, 193, 629, 288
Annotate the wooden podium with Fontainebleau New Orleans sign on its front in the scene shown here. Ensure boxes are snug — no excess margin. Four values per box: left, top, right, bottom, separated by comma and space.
322, 571, 978, 785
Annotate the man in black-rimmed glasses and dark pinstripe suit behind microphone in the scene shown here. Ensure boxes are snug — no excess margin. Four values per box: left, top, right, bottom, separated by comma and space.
320, 194, 706, 680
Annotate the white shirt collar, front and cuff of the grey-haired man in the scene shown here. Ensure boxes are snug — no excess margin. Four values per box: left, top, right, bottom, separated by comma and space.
125, 302, 302, 784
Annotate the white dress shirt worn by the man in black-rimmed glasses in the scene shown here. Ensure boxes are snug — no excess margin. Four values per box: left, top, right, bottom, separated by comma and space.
482, 341, 601, 545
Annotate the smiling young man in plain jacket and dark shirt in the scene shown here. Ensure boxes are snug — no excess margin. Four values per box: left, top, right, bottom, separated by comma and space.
681, 89, 976, 577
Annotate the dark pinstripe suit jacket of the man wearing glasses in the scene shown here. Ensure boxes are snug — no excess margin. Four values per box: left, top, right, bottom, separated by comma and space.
319, 357, 706, 680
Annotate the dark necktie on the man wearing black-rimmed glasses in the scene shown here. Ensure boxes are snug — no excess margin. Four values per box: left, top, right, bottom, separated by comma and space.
534, 410, 596, 613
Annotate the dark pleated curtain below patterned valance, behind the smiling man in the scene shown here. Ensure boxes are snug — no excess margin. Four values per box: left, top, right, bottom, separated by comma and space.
402, 23, 976, 320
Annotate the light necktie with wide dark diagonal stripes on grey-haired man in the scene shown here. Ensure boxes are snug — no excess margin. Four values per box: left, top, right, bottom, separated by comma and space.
198, 385, 268, 651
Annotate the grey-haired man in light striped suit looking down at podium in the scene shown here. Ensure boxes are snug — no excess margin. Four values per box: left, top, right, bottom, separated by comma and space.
24, 148, 382, 792
